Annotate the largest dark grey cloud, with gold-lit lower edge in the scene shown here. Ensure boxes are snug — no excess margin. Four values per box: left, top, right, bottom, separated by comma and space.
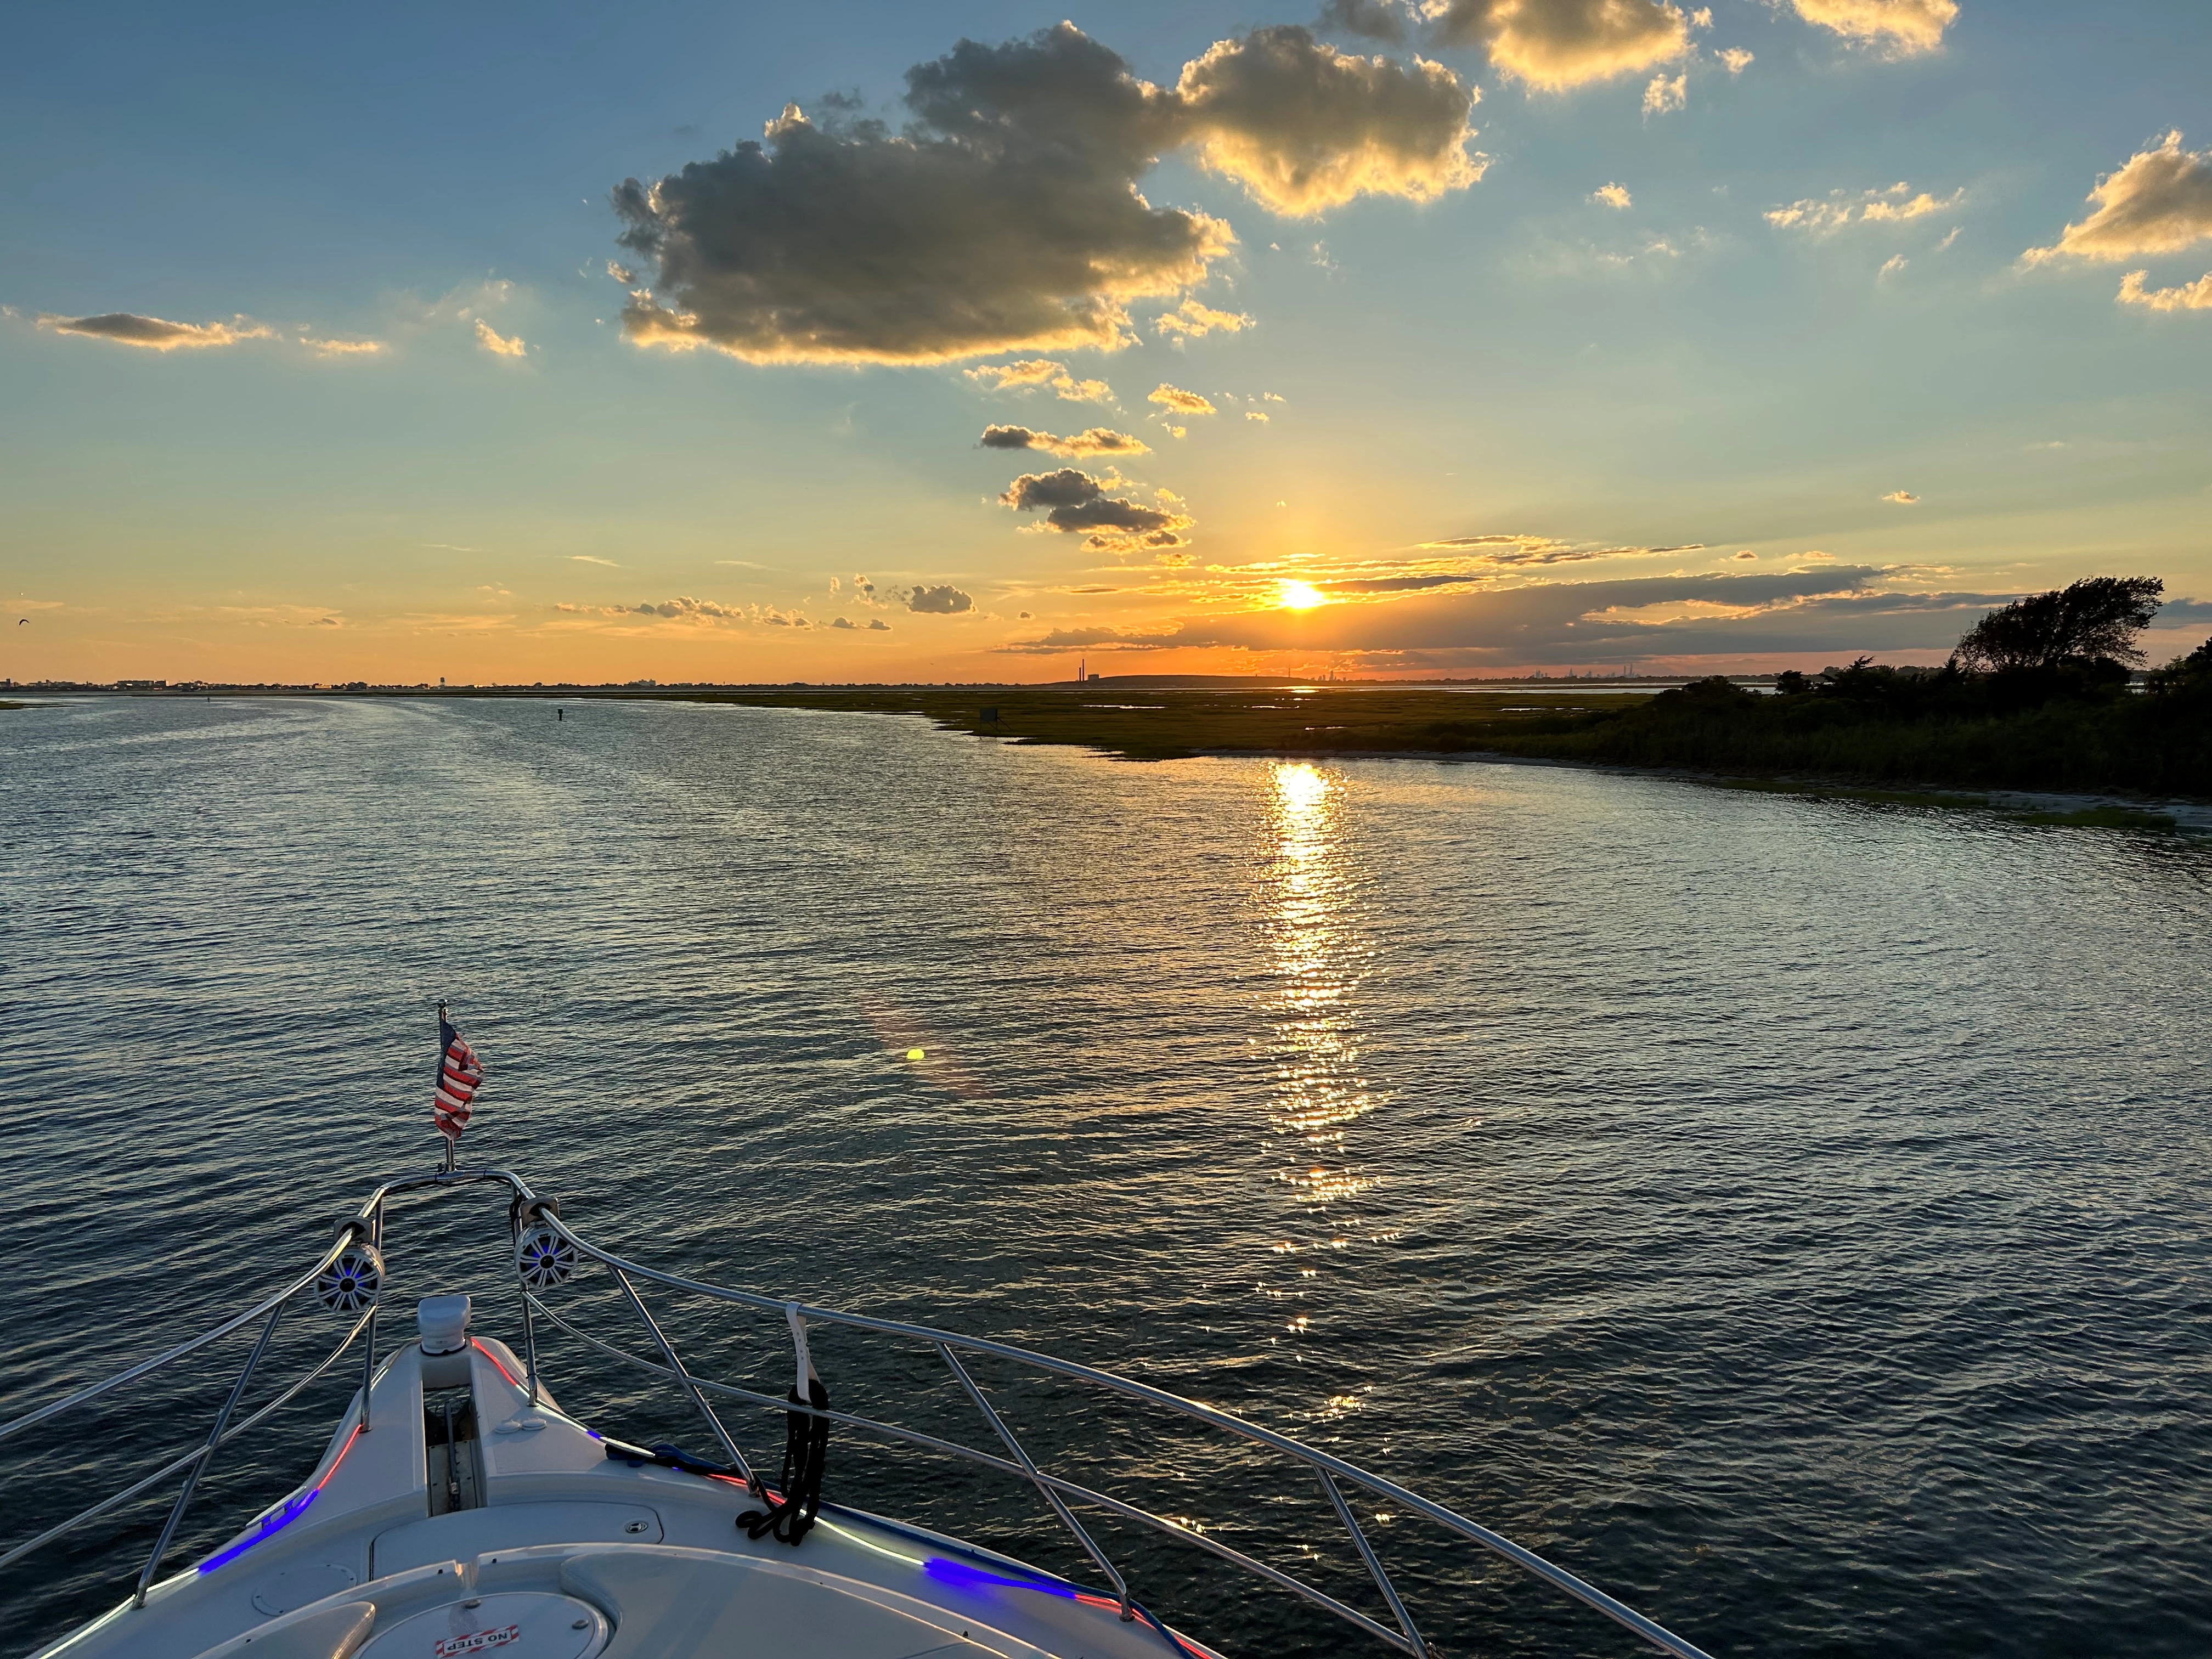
615, 24, 1234, 363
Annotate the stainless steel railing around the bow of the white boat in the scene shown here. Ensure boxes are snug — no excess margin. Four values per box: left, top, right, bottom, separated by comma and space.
0, 1168, 1708, 1659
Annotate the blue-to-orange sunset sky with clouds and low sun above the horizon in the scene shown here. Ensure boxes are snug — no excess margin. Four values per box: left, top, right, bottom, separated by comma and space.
0, 0, 2212, 684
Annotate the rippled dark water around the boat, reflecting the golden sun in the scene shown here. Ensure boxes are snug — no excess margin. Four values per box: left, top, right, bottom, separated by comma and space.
0, 701, 2212, 1657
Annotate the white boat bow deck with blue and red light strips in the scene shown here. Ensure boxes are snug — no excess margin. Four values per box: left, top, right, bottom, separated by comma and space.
40, 1338, 1212, 1659
